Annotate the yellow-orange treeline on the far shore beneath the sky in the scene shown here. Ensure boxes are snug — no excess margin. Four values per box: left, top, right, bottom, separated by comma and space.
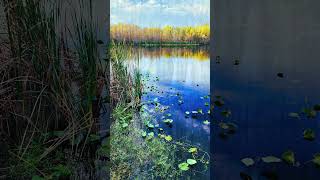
110, 23, 210, 45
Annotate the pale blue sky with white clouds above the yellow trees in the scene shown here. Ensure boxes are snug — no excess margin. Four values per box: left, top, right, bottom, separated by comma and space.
110, 0, 210, 27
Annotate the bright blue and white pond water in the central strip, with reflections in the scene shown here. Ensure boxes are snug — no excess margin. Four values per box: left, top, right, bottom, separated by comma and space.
126, 47, 210, 179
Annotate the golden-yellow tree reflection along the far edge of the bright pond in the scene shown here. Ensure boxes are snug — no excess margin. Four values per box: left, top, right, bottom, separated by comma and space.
133, 47, 209, 60
